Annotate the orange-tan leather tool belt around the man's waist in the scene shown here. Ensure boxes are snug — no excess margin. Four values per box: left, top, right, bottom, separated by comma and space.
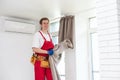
31, 54, 50, 68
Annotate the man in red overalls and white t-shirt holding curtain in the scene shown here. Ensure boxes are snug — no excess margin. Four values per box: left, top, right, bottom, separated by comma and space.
32, 17, 54, 80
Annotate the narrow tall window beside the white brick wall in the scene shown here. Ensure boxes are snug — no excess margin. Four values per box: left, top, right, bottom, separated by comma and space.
89, 17, 100, 80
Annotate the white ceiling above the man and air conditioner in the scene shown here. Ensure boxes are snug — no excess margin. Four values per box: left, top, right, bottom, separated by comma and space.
0, 0, 95, 20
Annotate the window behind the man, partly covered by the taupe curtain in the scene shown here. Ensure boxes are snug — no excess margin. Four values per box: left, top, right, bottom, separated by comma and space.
50, 21, 65, 80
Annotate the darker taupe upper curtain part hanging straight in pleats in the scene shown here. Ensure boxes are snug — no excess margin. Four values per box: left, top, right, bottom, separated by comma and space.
58, 16, 74, 48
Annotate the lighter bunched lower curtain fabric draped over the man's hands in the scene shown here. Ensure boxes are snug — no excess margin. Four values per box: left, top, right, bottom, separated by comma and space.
49, 39, 73, 80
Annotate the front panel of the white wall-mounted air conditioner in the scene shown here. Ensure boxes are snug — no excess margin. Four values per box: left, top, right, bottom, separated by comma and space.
4, 20, 35, 34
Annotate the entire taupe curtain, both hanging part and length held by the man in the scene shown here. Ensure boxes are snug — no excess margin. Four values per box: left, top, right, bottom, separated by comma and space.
49, 16, 74, 80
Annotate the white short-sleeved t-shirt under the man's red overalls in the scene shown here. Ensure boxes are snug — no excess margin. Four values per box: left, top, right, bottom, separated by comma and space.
32, 31, 51, 48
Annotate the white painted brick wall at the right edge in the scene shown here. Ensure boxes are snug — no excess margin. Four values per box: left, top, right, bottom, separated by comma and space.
96, 0, 120, 80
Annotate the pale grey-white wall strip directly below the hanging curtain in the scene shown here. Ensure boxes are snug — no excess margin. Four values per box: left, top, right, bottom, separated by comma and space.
65, 49, 76, 80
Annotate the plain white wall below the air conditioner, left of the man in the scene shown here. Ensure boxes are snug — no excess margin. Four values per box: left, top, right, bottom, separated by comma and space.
0, 19, 34, 80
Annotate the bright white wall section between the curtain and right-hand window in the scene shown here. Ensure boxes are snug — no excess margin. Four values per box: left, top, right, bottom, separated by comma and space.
75, 8, 96, 80
